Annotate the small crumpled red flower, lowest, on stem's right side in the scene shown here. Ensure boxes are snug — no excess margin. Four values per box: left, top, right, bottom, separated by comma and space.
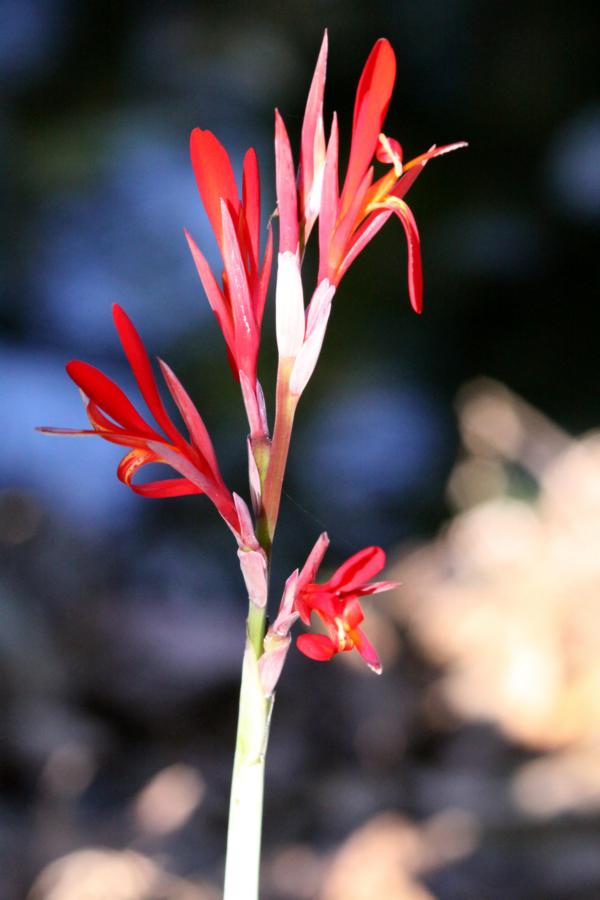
295, 536, 397, 674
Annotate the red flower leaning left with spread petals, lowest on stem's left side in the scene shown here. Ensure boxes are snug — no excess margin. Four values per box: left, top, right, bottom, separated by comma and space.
40, 304, 240, 535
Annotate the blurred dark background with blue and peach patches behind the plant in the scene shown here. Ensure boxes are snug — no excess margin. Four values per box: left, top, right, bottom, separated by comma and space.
0, 0, 600, 900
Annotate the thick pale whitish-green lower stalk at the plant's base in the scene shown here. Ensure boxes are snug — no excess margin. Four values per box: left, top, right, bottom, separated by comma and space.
223, 604, 273, 900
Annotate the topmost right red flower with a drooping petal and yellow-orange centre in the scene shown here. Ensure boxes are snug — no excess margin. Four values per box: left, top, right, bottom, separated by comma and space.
319, 38, 466, 312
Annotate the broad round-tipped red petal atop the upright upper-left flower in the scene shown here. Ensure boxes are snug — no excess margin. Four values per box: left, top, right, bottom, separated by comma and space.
190, 128, 240, 246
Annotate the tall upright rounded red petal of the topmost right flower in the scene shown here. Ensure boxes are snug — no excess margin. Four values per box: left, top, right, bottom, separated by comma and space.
341, 38, 396, 220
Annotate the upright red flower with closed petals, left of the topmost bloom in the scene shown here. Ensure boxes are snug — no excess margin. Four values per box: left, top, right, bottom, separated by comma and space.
186, 128, 272, 391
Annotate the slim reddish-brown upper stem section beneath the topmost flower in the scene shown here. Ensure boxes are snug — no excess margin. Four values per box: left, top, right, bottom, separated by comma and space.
263, 359, 298, 541
